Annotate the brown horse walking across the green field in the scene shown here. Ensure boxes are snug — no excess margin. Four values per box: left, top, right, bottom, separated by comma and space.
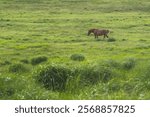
88, 29, 109, 39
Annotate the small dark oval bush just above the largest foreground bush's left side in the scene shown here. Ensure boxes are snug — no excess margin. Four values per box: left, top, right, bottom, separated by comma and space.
31, 56, 47, 65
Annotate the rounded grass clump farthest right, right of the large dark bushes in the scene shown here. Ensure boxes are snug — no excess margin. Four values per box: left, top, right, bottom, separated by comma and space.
122, 58, 136, 70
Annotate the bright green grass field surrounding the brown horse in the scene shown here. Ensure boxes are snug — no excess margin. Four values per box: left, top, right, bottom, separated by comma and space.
0, 0, 150, 99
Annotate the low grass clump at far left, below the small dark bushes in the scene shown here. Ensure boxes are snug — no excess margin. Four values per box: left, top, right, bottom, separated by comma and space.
9, 63, 27, 73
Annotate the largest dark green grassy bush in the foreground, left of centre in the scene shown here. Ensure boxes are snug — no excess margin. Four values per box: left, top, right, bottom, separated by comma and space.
34, 65, 71, 91
